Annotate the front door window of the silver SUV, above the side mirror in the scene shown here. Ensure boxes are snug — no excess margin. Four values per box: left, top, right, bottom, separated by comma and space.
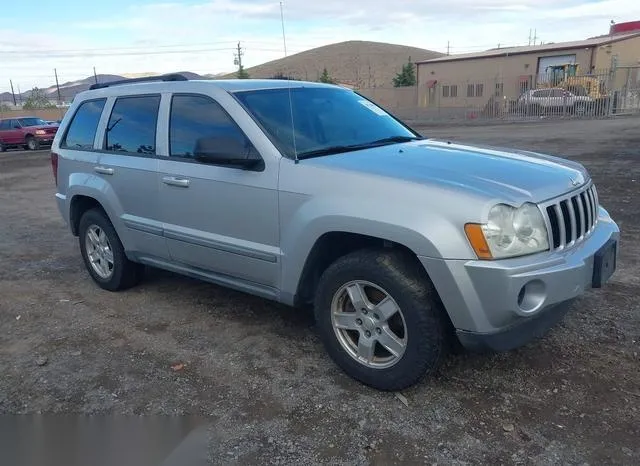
169, 95, 246, 158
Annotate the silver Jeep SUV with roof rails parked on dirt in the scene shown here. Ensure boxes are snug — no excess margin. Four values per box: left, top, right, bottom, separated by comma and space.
51, 75, 619, 390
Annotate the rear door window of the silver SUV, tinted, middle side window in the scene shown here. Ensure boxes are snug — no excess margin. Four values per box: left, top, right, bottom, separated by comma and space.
104, 95, 160, 155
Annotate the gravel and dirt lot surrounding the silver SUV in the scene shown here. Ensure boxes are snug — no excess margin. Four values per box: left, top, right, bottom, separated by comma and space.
0, 119, 640, 465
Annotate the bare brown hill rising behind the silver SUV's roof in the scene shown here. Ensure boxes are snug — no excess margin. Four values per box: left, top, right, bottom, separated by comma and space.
226, 41, 444, 88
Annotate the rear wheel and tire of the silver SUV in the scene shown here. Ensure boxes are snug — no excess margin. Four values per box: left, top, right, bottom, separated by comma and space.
78, 209, 144, 291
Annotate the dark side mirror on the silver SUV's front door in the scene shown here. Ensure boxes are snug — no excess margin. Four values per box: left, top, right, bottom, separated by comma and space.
194, 137, 264, 170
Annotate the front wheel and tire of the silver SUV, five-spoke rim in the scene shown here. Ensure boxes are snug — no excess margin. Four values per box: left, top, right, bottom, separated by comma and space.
314, 249, 449, 390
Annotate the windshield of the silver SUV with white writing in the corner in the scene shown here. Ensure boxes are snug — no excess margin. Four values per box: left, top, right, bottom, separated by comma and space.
235, 87, 419, 158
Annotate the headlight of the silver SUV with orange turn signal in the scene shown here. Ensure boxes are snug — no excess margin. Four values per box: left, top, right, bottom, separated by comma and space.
465, 203, 549, 259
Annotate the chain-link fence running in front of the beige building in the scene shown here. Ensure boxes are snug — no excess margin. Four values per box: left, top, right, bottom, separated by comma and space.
359, 66, 640, 121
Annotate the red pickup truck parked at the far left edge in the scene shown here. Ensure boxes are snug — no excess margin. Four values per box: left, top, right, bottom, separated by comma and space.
0, 117, 58, 152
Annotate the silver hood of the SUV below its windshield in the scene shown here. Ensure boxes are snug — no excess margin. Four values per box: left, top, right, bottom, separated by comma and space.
303, 139, 589, 202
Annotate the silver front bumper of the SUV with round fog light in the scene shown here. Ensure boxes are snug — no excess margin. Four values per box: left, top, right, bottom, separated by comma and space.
420, 208, 620, 349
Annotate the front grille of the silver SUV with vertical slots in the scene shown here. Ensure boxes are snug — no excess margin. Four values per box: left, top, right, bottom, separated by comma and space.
543, 184, 598, 249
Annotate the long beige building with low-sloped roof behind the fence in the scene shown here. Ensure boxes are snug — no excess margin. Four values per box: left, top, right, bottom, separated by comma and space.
417, 28, 640, 110
